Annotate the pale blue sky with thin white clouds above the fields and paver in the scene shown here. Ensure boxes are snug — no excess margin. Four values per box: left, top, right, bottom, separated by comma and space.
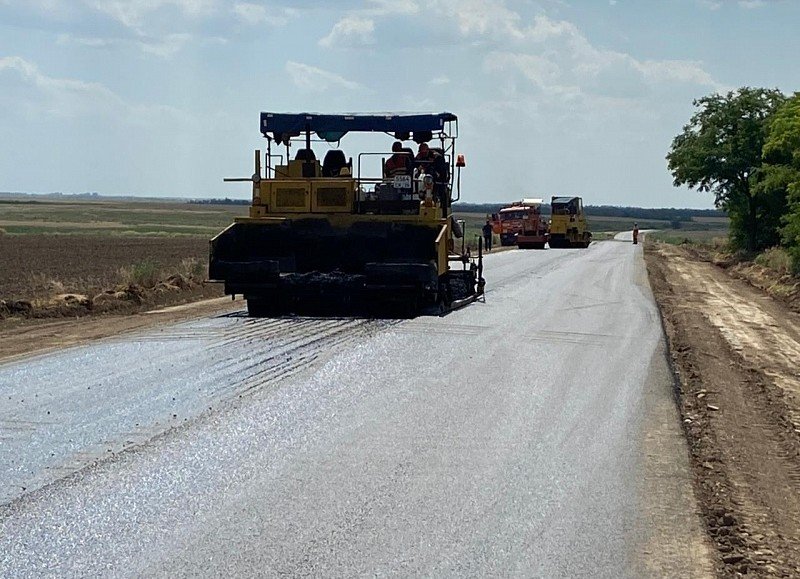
0, 0, 800, 207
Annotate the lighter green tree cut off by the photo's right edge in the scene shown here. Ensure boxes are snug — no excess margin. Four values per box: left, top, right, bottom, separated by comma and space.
764, 93, 800, 273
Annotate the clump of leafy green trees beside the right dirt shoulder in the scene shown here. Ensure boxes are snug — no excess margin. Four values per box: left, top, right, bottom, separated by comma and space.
667, 87, 800, 273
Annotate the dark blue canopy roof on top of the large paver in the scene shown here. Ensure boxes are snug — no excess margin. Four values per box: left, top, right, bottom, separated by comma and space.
261, 113, 457, 141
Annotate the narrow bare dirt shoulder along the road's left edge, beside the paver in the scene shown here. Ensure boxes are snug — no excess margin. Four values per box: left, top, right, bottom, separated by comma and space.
0, 297, 244, 362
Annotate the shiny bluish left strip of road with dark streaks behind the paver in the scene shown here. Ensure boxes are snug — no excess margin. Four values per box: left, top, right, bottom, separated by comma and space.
0, 315, 399, 503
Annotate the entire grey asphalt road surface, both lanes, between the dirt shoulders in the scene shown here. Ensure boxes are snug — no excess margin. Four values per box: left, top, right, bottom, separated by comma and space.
0, 241, 709, 577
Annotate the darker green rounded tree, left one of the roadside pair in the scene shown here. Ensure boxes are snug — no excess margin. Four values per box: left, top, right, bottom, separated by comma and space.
667, 87, 786, 251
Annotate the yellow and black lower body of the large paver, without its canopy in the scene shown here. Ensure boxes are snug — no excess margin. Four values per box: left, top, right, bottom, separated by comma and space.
209, 113, 483, 316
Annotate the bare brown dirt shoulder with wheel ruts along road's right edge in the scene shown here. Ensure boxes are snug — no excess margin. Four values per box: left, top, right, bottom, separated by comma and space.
645, 244, 800, 577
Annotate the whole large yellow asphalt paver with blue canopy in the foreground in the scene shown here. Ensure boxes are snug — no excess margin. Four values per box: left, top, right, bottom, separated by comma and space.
209, 112, 484, 317
